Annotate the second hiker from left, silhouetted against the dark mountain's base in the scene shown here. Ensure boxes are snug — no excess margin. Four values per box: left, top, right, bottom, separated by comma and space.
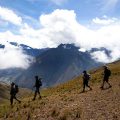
33, 76, 42, 100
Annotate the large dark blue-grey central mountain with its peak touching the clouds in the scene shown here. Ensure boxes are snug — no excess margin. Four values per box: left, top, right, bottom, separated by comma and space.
16, 44, 101, 88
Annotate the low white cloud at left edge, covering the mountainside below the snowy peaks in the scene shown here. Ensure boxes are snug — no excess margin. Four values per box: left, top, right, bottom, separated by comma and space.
0, 43, 33, 69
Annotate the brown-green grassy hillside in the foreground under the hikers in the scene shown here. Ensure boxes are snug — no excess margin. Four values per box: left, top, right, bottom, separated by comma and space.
0, 61, 120, 120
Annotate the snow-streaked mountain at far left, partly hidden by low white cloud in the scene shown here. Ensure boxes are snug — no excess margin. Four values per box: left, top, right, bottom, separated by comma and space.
0, 42, 49, 83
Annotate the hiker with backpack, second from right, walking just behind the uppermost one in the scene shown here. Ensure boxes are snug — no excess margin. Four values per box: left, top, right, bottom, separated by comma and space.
82, 70, 92, 92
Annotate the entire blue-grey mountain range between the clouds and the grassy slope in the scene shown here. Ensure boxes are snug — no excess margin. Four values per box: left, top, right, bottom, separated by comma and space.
0, 43, 110, 88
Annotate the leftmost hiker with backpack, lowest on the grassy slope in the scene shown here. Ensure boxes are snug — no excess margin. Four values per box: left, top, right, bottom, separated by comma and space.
10, 82, 21, 105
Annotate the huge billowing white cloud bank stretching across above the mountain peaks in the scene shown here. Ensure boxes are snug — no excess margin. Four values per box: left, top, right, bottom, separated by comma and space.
0, 9, 120, 69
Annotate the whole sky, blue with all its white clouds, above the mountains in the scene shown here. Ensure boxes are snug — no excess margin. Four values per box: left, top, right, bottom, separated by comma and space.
0, 0, 120, 69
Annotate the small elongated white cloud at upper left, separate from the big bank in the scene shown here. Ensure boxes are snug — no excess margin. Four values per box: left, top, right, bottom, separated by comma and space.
0, 7, 22, 25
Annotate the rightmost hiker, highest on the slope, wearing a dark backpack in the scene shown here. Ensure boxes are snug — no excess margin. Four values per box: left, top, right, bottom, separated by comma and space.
100, 66, 112, 89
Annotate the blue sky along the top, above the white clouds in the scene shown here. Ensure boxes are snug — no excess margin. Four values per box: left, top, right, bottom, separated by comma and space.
0, 0, 120, 22
